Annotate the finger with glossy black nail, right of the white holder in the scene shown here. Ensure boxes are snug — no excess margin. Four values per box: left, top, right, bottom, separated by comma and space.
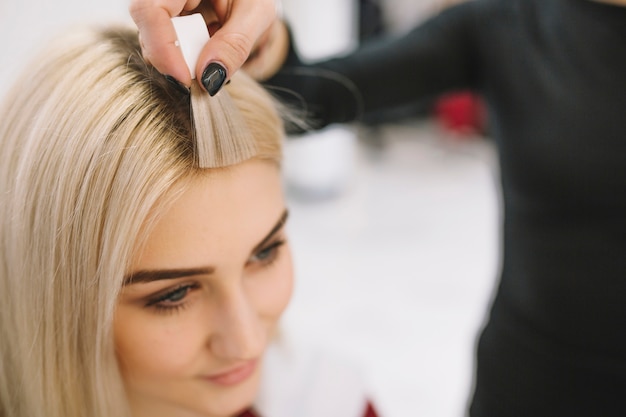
196, 0, 276, 95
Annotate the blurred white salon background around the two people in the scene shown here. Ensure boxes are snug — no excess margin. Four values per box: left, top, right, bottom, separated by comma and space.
0, 0, 499, 417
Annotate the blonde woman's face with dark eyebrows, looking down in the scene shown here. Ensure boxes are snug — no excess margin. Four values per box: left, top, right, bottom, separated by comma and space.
114, 161, 292, 417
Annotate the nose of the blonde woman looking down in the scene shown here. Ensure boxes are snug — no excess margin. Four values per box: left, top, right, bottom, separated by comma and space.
209, 290, 267, 360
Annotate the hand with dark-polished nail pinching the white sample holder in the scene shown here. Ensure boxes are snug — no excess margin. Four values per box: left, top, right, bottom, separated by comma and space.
129, 0, 276, 95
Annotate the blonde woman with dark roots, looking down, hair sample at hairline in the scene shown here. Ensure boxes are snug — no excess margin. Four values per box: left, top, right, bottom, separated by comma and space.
0, 27, 374, 417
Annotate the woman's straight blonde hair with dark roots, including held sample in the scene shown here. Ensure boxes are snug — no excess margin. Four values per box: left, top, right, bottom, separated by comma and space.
0, 27, 282, 417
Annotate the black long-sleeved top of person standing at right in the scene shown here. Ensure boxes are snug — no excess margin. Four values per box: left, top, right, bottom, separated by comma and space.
249, 0, 626, 417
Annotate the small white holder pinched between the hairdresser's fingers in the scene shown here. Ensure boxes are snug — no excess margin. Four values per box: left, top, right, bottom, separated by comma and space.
171, 13, 209, 79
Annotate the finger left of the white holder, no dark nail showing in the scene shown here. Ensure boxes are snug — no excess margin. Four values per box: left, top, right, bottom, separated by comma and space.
129, 0, 197, 86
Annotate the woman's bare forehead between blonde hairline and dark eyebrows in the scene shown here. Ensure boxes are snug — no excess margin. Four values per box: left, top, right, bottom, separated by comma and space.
132, 160, 285, 270
